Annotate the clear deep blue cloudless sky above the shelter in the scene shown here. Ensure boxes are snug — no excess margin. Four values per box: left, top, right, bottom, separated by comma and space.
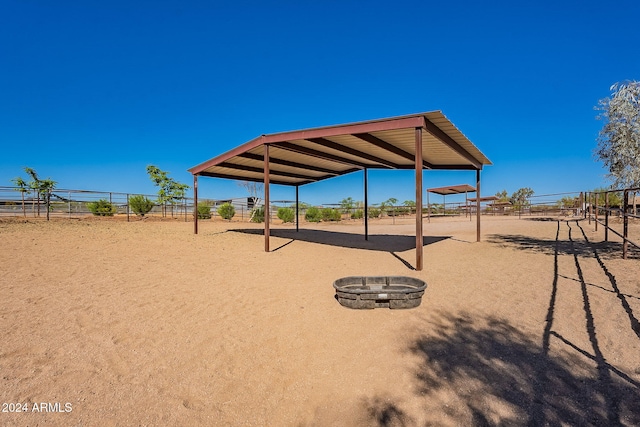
0, 0, 640, 207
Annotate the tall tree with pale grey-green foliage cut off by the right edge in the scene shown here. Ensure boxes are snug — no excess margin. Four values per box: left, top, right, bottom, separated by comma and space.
595, 81, 640, 212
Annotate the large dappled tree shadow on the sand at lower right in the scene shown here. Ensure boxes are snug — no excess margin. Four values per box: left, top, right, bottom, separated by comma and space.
400, 315, 640, 426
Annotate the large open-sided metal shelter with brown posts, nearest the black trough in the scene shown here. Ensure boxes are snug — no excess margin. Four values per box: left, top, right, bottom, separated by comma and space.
189, 111, 491, 270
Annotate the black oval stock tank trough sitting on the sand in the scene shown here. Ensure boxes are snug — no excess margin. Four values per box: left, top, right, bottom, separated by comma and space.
333, 276, 427, 309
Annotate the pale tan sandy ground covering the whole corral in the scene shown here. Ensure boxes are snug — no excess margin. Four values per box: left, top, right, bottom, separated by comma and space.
0, 217, 640, 426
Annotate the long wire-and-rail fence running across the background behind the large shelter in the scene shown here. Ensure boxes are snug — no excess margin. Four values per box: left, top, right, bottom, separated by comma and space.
0, 187, 640, 247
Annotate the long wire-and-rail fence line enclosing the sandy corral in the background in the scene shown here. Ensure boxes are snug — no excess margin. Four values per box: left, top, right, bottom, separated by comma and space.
0, 187, 640, 254
